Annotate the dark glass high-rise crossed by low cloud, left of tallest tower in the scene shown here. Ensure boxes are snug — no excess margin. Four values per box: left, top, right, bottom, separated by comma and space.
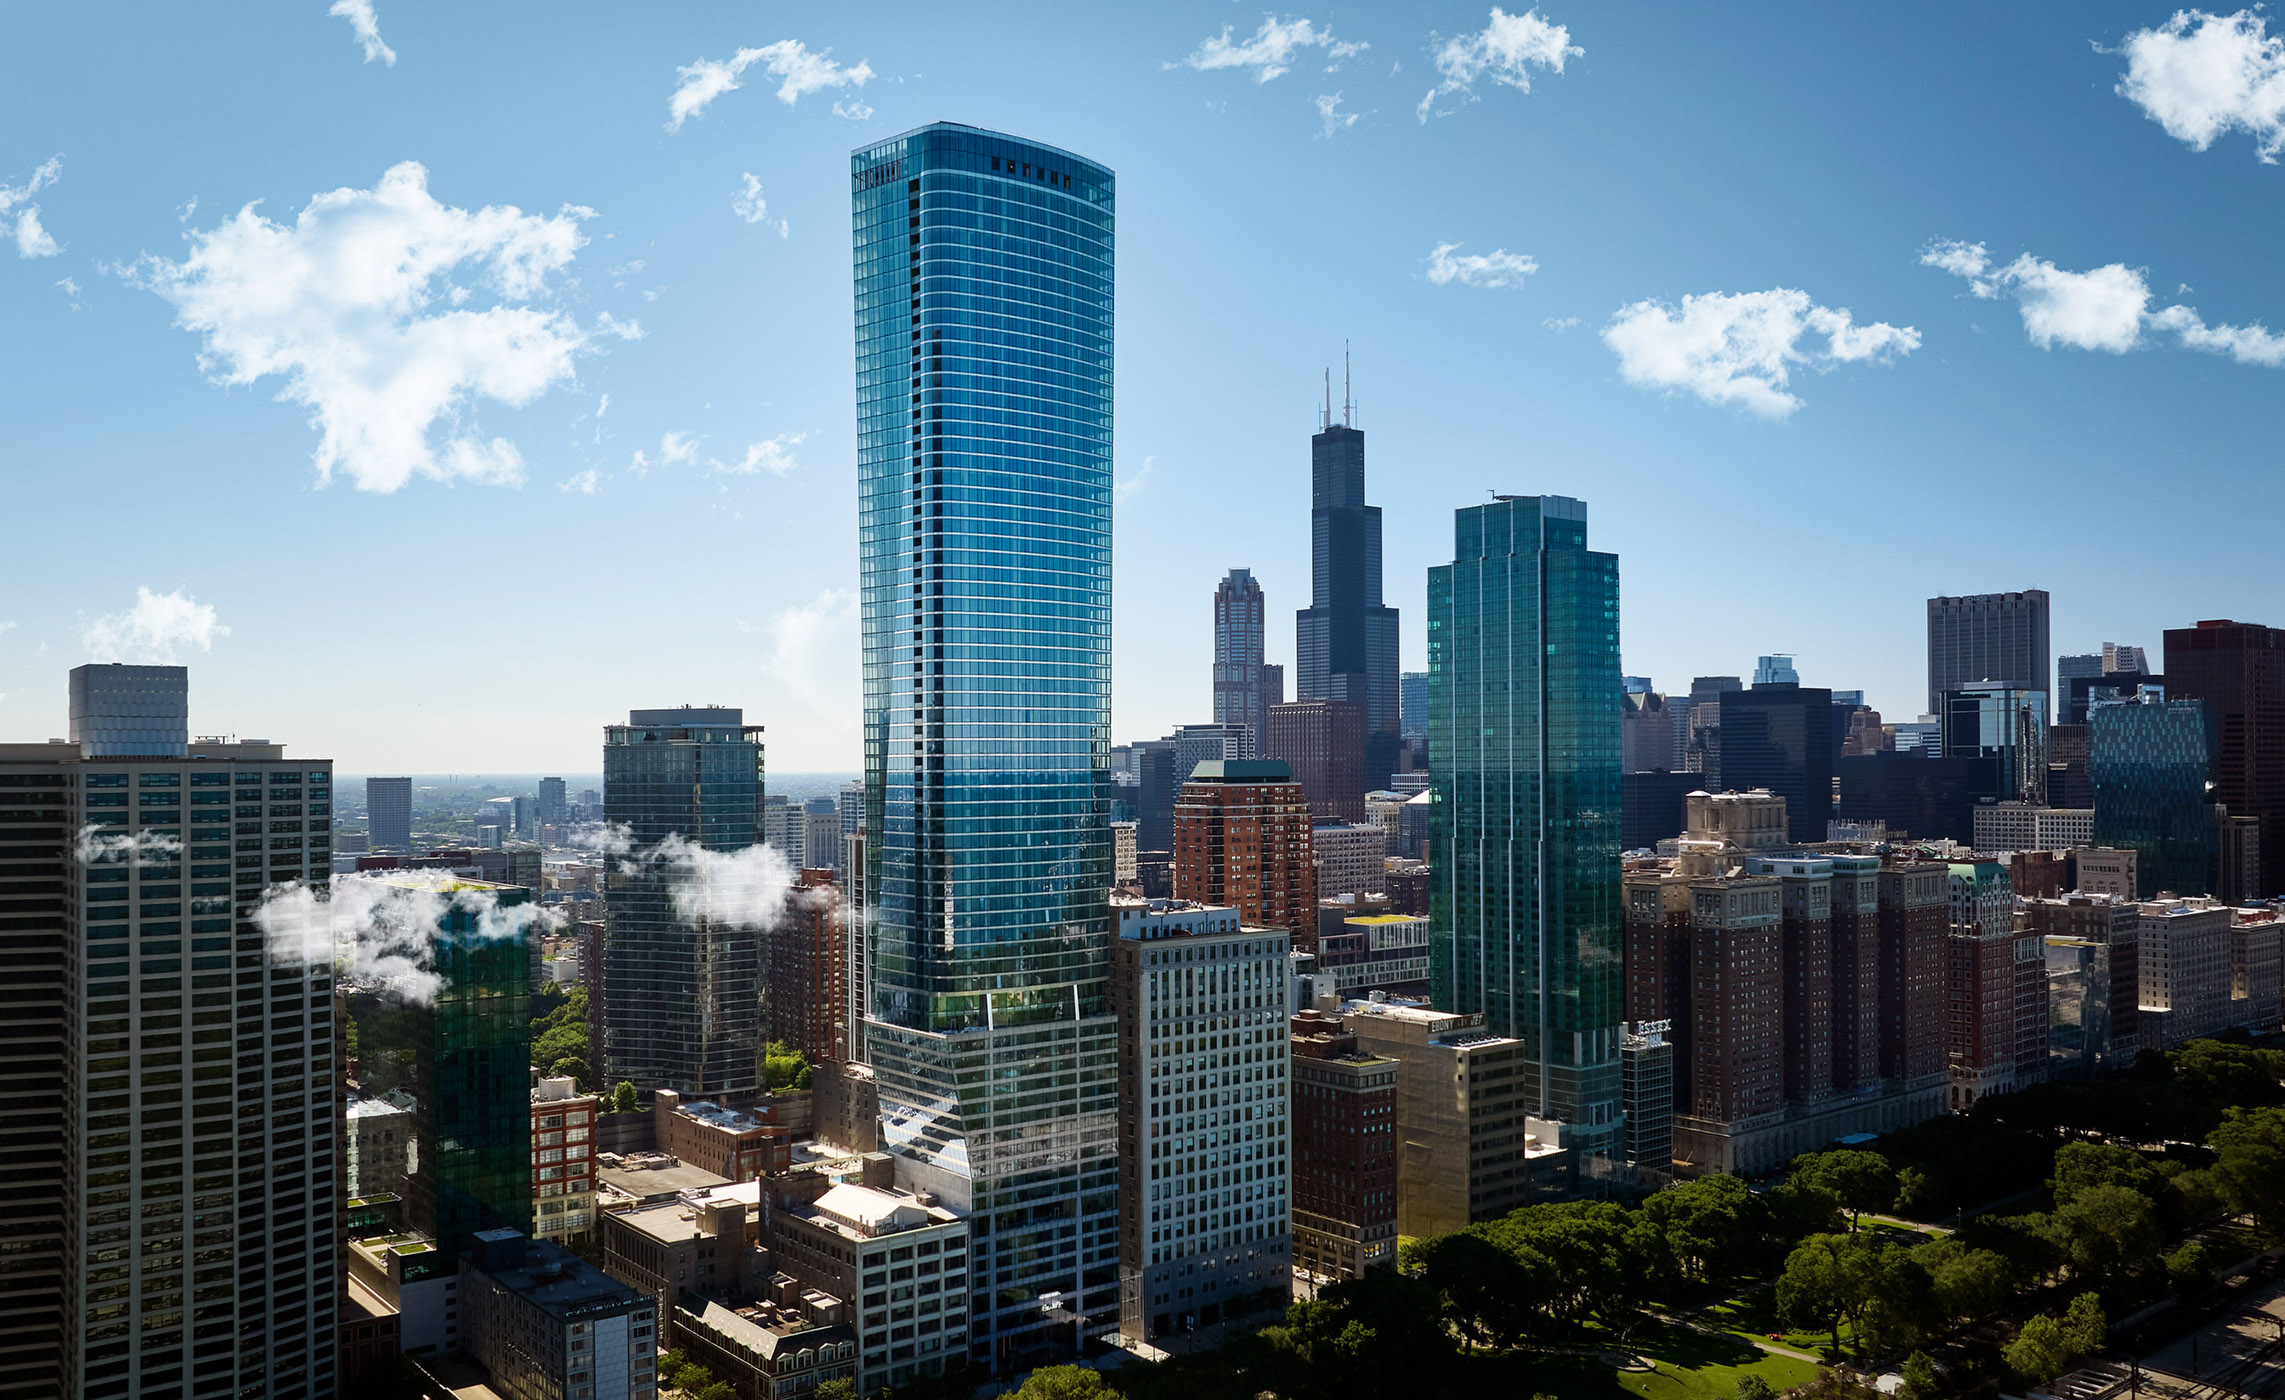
601, 706, 763, 1094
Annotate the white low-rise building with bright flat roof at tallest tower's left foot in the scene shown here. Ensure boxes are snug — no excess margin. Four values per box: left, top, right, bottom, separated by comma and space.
768, 1183, 969, 1395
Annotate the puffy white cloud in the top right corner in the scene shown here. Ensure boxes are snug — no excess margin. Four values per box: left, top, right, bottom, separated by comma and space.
2114, 9, 2285, 164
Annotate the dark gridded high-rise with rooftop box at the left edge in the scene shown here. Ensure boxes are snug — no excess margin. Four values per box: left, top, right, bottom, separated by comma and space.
0, 665, 340, 1400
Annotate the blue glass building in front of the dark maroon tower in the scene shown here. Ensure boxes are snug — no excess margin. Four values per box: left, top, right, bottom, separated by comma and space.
2079, 697, 2219, 895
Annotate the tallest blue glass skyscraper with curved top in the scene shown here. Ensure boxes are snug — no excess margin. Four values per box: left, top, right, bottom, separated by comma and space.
850, 123, 1119, 1370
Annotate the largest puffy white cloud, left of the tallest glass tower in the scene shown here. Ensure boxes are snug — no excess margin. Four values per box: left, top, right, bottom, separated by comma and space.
117, 160, 607, 491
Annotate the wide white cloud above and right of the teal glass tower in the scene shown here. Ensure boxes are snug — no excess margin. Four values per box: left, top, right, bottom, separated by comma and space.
1602, 288, 1919, 418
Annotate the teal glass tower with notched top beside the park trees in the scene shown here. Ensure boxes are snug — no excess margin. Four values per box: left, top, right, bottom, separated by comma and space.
1428, 496, 1622, 1185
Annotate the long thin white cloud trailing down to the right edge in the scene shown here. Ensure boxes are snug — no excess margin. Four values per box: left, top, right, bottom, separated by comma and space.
1919, 242, 2285, 370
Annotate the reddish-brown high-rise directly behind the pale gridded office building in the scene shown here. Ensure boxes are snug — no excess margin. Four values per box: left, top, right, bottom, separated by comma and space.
1172, 758, 1316, 948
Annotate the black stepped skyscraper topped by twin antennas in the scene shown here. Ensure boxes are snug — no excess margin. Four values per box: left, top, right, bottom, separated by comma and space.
1293, 388, 1401, 790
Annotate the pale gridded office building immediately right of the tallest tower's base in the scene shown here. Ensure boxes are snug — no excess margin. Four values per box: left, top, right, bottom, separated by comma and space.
1111, 900, 1293, 1350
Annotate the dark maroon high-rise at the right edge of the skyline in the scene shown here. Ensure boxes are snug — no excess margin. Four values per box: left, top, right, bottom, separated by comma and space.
2166, 621, 2285, 895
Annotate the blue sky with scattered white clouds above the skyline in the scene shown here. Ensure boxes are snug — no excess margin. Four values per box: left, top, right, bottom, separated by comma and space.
0, 0, 2285, 772
